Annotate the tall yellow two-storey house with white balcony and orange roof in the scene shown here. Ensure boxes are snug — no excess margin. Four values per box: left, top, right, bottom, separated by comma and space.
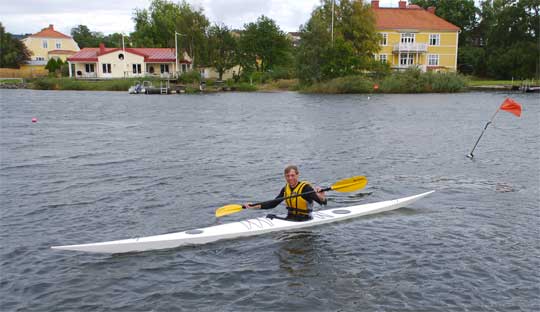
371, 0, 460, 71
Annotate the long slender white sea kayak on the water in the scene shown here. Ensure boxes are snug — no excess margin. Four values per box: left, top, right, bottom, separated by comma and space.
51, 191, 434, 254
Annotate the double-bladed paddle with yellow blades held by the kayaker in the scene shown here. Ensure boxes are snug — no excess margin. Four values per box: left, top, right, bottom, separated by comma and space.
216, 176, 367, 218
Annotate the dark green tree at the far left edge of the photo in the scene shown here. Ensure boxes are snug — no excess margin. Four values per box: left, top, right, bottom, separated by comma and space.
0, 22, 32, 68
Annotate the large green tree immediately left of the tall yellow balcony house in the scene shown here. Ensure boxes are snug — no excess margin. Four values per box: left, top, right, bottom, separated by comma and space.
297, 0, 380, 83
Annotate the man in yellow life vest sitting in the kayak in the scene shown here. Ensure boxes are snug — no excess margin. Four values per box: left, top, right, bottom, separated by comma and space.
243, 165, 327, 221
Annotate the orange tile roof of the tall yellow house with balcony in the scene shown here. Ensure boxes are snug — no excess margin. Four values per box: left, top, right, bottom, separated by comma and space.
373, 6, 459, 31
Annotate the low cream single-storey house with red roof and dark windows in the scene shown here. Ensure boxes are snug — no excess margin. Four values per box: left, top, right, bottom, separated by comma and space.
67, 43, 192, 79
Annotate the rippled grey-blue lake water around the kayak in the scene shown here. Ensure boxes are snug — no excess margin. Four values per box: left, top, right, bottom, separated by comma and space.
0, 90, 540, 311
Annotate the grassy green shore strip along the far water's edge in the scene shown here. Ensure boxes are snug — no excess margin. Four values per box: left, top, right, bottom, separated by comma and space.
0, 73, 538, 94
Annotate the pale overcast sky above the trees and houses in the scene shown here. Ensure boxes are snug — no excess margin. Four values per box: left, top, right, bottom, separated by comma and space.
0, 0, 398, 35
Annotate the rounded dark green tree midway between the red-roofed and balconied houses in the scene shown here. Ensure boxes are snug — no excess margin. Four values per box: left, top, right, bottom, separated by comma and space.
239, 15, 292, 72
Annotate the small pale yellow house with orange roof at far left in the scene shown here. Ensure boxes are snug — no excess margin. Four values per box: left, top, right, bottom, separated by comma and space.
22, 25, 80, 66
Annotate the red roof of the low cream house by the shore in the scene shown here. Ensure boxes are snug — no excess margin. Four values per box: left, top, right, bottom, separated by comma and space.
68, 47, 185, 63
